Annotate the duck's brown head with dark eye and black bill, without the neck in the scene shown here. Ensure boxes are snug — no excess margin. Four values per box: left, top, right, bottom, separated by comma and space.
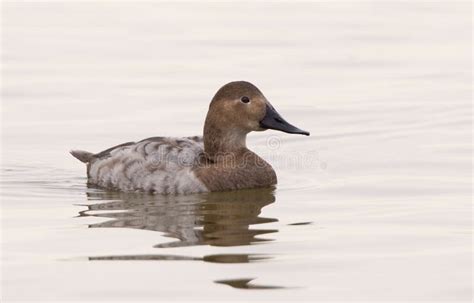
205, 81, 309, 136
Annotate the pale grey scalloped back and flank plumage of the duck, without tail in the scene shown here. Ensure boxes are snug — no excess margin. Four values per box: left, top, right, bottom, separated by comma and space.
78, 136, 206, 193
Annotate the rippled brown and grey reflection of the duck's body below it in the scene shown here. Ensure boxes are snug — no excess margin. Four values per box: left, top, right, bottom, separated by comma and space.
79, 188, 278, 263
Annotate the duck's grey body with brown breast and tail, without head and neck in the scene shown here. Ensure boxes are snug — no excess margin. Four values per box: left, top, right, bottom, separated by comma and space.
72, 136, 277, 194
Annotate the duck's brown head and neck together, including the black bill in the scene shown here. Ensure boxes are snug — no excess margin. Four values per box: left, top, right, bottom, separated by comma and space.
204, 81, 309, 158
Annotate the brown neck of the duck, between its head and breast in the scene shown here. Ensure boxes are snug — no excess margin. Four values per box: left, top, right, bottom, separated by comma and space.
204, 123, 247, 162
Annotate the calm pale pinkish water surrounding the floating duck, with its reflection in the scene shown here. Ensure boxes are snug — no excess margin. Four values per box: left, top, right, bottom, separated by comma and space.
1, 2, 472, 302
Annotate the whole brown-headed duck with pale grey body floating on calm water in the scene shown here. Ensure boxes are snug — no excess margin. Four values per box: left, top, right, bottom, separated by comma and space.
71, 81, 309, 194
